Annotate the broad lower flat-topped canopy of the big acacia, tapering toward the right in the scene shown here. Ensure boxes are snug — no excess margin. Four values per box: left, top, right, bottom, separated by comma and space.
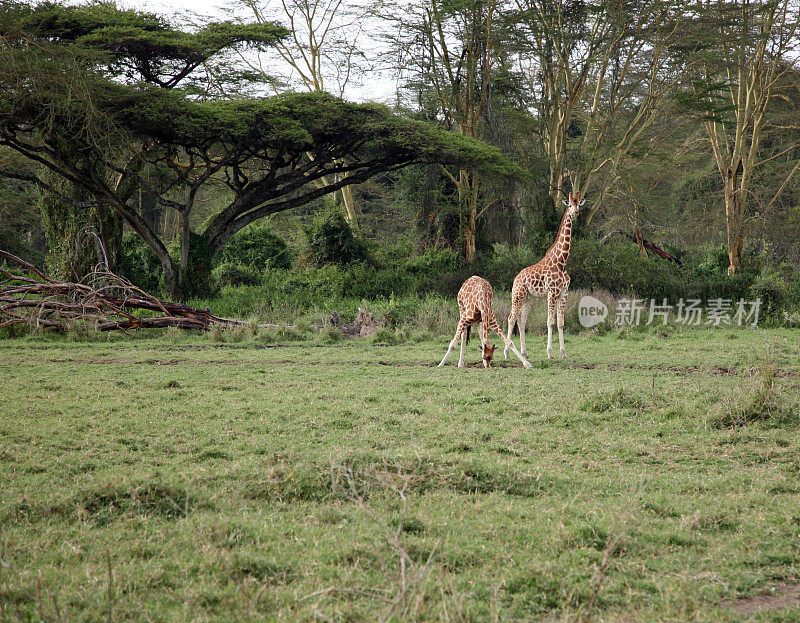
110, 90, 524, 253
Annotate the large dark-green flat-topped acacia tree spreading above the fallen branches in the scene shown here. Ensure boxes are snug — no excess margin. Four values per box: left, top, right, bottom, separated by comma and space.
0, 0, 517, 296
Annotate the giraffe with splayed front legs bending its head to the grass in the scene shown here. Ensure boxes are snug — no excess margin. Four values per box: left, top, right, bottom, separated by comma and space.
439, 276, 531, 368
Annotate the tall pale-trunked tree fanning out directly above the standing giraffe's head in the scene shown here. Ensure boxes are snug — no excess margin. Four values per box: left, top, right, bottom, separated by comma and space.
508, 0, 686, 222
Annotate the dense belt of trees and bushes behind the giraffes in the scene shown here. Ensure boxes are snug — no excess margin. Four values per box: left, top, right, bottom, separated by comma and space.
0, 0, 800, 332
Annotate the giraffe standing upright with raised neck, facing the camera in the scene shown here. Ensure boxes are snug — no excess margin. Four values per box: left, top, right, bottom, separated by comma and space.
503, 193, 586, 359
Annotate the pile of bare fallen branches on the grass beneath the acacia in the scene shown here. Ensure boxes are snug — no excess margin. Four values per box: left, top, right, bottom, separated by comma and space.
0, 249, 243, 332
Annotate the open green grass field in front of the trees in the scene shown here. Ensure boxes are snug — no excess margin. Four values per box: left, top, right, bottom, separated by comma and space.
0, 329, 800, 622
